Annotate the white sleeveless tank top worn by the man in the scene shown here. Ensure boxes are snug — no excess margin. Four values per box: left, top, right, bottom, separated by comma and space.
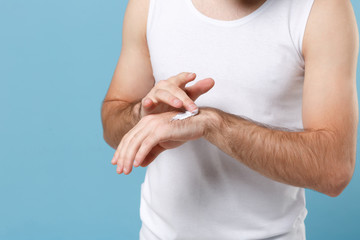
140, 0, 314, 240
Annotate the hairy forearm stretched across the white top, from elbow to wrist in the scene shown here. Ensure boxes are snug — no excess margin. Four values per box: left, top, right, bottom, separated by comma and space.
201, 108, 350, 196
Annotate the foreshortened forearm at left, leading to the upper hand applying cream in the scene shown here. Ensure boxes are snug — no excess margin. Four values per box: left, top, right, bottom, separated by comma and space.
101, 100, 141, 149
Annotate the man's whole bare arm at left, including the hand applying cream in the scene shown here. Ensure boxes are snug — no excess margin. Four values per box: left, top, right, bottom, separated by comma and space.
101, 0, 214, 148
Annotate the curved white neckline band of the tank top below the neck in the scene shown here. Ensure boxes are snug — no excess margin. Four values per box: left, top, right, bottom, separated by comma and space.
185, 0, 271, 27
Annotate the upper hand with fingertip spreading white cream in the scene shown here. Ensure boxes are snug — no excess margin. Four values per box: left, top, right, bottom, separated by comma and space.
140, 72, 215, 119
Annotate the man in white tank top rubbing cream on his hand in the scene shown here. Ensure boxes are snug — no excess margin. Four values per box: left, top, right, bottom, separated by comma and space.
102, 0, 358, 240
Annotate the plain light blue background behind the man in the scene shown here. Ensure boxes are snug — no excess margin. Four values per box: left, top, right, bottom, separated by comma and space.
0, 0, 360, 240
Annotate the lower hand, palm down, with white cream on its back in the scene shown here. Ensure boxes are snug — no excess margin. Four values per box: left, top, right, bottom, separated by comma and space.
111, 110, 206, 175
